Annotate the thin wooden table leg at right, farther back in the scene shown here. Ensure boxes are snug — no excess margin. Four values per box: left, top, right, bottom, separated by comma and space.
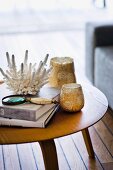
82, 128, 94, 158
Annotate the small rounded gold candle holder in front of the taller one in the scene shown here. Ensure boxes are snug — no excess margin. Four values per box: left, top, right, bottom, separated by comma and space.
60, 83, 84, 112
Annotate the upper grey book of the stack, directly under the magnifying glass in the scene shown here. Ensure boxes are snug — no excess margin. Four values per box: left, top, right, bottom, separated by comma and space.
0, 87, 59, 121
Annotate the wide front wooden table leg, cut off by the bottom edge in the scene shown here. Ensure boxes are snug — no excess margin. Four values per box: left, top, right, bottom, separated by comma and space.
39, 140, 59, 170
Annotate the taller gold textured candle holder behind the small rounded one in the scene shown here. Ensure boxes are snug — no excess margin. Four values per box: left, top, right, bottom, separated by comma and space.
49, 57, 76, 87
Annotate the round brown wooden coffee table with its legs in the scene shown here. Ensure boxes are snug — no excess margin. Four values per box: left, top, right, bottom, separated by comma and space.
0, 84, 108, 170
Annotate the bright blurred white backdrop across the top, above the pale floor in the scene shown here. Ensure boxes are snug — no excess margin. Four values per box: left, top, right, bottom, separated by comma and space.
0, 0, 113, 33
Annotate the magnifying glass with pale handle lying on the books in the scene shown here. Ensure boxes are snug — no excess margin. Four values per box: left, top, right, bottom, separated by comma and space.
2, 95, 58, 105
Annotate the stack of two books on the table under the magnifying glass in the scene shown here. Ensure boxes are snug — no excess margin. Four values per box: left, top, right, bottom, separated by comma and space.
0, 86, 59, 128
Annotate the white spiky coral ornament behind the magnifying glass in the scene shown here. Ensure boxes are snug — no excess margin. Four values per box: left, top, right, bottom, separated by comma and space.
0, 50, 50, 95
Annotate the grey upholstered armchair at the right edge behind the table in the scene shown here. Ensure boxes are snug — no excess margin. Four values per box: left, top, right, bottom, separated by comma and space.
85, 23, 113, 109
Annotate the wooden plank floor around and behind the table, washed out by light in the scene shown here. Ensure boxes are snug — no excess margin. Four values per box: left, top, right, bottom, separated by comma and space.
0, 31, 113, 170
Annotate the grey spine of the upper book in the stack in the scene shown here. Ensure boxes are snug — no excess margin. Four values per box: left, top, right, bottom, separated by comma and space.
0, 106, 36, 121
